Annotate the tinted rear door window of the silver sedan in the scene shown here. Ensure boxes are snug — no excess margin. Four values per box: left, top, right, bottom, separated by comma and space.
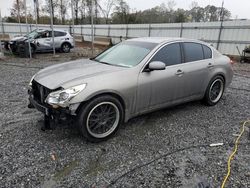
183, 42, 203, 62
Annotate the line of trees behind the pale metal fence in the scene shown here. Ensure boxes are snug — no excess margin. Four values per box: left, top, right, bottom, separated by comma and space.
4, 0, 231, 25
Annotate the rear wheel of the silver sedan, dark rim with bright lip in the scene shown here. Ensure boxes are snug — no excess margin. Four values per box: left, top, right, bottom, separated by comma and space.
203, 75, 225, 106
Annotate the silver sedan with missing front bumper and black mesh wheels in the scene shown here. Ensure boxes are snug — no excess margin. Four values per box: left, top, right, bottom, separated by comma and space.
29, 38, 233, 142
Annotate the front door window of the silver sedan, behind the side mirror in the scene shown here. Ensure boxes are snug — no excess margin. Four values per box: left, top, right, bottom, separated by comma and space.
151, 43, 181, 66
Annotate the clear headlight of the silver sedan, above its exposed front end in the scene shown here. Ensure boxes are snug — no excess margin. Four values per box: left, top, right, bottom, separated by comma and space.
45, 84, 87, 107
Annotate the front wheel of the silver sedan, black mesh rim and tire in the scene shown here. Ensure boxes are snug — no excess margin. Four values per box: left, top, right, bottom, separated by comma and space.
77, 95, 124, 142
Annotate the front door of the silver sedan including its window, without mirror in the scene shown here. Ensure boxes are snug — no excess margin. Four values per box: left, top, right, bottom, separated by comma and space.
137, 43, 184, 112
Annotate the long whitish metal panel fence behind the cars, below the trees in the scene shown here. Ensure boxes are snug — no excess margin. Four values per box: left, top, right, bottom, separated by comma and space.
0, 20, 250, 55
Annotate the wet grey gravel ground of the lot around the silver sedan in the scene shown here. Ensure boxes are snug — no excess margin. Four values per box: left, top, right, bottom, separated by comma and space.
0, 49, 250, 188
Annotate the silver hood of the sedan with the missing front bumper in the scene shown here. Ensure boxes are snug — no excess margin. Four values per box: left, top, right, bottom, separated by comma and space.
34, 59, 126, 90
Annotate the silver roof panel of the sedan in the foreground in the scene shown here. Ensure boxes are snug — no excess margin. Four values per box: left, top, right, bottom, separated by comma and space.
127, 37, 204, 44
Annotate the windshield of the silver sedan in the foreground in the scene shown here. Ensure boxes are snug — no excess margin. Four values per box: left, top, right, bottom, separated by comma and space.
94, 41, 157, 67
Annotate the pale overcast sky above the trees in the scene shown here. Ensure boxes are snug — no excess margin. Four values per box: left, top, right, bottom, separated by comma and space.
0, 0, 250, 19
